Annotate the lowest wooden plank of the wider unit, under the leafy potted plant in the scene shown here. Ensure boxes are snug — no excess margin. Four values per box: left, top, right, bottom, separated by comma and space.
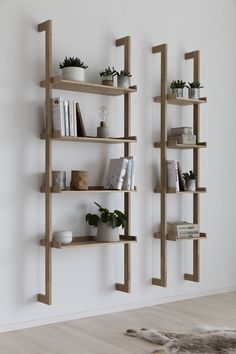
40, 235, 137, 249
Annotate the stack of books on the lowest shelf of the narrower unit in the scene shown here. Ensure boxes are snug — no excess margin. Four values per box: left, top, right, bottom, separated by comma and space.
167, 221, 200, 238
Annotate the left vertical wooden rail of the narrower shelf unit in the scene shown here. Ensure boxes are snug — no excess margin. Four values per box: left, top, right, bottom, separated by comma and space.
152, 44, 167, 287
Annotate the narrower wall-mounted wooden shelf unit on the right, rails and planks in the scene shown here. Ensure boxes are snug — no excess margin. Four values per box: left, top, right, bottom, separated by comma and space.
152, 44, 207, 287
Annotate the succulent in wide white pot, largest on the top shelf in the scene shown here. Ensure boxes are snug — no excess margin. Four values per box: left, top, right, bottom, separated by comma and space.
59, 57, 88, 81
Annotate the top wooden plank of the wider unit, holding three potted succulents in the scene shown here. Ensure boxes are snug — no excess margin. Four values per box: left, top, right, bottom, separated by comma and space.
40, 75, 137, 96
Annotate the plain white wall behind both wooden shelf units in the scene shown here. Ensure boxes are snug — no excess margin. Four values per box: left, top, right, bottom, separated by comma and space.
0, 0, 236, 330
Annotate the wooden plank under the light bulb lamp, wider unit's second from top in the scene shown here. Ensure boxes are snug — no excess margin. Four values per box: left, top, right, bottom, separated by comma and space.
40, 132, 137, 144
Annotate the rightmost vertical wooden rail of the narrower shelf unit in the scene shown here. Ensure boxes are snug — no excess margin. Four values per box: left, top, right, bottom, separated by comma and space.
184, 50, 200, 282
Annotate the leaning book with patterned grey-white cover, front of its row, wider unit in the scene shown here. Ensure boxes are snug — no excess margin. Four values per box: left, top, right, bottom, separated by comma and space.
104, 158, 128, 190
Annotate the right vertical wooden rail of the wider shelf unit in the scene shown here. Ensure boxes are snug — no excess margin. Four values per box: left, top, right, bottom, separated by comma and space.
116, 36, 131, 293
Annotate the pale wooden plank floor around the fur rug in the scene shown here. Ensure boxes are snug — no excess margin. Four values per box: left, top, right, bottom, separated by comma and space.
0, 292, 236, 354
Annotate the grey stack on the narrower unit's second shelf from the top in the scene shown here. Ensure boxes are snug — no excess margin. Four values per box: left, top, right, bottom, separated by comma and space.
168, 127, 196, 145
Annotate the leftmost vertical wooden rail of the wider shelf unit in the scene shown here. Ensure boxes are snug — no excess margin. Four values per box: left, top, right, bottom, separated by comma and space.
38, 20, 52, 305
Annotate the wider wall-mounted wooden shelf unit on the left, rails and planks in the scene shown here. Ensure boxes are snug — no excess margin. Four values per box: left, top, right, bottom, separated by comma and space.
38, 20, 137, 305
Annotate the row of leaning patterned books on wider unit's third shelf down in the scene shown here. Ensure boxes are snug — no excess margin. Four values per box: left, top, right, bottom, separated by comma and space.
104, 156, 135, 190
